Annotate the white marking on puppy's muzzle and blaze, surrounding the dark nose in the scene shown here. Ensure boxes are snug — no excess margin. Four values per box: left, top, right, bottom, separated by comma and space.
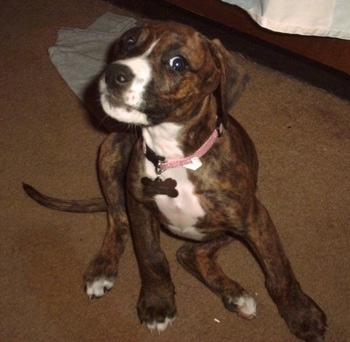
99, 42, 157, 125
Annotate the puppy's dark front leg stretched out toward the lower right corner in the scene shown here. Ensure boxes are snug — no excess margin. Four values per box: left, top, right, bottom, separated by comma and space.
246, 201, 326, 341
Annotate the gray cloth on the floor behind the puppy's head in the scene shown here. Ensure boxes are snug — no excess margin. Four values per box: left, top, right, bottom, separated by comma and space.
49, 13, 136, 102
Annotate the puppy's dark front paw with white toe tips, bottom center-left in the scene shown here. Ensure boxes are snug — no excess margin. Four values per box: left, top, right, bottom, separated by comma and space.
137, 289, 176, 332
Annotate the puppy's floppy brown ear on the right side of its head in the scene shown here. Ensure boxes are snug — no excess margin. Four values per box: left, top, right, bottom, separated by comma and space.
210, 39, 248, 126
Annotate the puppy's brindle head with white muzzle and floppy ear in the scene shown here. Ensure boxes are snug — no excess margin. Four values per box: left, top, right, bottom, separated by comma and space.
100, 21, 246, 126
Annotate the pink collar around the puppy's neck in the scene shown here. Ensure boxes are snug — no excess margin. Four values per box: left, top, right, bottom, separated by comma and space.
143, 122, 224, 175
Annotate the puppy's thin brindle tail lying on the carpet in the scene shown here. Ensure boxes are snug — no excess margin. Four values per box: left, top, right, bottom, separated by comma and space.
23, 183, 107, 213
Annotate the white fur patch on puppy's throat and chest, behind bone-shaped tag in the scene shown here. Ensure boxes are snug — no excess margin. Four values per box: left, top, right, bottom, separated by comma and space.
143, 123, 205, 240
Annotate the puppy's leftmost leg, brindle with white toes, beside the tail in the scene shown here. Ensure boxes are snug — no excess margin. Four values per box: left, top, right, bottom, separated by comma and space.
84, 132, 136, 298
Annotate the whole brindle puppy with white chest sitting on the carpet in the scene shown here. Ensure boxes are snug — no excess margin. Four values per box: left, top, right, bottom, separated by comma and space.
24, 22, 326, 341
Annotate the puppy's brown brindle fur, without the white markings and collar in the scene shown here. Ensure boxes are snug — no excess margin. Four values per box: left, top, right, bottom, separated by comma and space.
25, 22, 326, 341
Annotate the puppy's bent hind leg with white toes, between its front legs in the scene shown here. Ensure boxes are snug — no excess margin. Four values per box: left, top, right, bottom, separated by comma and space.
177, 235, 256, 319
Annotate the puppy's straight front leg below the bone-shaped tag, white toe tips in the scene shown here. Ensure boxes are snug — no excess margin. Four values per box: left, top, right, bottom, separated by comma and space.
128, 196, 176, 331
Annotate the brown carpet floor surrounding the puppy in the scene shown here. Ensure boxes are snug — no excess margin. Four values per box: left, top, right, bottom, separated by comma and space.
0, 0, 350, 342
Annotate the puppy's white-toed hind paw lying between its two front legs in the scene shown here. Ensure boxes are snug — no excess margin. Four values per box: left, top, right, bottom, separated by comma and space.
223, 293, 256, 319
